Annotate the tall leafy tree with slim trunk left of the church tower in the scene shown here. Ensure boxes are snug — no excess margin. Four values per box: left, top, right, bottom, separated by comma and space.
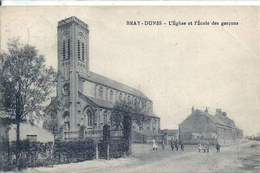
0, 38, 57, 169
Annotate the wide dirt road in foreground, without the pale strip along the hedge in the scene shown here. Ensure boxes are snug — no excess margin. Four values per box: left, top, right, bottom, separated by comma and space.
87, 141, 260, 173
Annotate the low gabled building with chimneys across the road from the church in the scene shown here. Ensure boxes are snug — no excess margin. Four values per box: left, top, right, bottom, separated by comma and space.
179, 107, 243, 145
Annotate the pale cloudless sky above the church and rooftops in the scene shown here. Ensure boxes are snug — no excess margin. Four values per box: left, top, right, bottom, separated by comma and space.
1, 6, 260, 135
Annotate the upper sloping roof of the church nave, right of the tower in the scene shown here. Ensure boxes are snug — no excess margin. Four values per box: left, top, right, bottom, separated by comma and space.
79, 72, 151, 101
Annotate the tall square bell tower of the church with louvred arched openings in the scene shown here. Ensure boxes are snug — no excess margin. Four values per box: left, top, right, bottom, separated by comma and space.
57, 16, 89, 133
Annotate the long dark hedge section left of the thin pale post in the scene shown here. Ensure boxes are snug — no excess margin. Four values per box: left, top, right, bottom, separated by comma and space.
0, 139, 95, 171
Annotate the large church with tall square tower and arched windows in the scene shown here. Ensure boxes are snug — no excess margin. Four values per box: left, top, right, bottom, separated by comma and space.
56, 16, 160, 140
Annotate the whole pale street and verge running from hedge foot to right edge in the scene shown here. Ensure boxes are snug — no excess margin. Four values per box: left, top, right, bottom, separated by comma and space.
15, 140, 260, 173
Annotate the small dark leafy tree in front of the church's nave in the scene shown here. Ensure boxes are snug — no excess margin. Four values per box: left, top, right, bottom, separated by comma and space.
111, 98, 151, 156
